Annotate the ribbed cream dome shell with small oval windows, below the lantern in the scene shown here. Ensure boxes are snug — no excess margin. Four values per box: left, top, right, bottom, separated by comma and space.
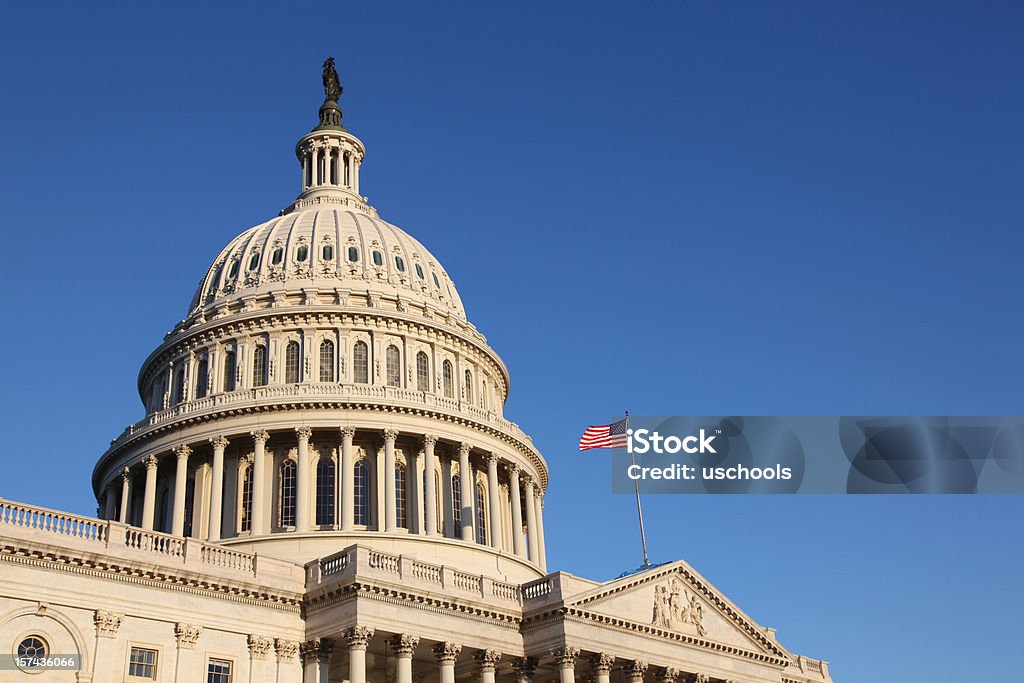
189, 205, 466, 321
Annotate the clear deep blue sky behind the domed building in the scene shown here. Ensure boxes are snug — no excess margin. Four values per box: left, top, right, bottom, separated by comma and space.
0, 1, 1024, 683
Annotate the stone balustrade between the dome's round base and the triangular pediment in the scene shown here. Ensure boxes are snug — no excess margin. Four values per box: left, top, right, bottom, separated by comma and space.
306, 545, 528, 605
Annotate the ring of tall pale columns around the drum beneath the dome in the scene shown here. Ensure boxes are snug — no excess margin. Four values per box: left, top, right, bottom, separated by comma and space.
104, 426, 547, 568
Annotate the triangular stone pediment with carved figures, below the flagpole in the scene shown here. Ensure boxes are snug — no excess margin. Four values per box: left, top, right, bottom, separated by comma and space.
565, 560, 791, 659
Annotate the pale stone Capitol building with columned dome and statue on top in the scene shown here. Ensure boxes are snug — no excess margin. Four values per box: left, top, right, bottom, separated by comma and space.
0, 65, 831, 683
